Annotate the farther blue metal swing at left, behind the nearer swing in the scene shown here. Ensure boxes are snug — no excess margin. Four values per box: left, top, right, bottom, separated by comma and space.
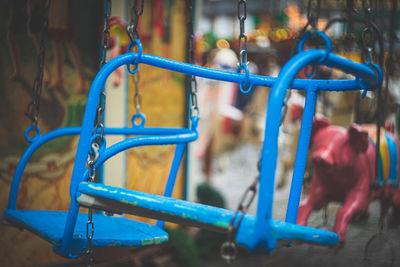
3, 124, 197, 258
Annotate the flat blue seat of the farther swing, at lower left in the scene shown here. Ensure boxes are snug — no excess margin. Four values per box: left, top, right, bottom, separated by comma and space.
3, 209, 168, 255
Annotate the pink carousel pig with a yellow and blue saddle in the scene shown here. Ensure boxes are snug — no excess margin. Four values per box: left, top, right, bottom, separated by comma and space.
297, 118, 400, 245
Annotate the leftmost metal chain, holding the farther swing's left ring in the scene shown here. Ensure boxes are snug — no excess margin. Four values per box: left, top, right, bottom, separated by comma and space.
24, 0, 50, 135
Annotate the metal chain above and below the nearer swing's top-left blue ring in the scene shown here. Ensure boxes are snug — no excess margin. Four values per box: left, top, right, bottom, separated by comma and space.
126, 0, 144, 114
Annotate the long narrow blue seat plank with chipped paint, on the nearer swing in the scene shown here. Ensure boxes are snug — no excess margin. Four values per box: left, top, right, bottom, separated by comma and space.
77, 182, 339, 249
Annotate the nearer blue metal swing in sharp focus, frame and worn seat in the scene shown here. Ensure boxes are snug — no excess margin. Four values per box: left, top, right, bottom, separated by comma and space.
73, 49, 382, 255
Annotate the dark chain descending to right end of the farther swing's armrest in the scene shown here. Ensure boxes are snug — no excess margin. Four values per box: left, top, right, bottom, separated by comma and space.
188, 0, 200, 118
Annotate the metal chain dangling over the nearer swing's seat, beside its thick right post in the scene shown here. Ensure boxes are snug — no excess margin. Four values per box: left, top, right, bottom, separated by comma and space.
220, 159, 261, 265
